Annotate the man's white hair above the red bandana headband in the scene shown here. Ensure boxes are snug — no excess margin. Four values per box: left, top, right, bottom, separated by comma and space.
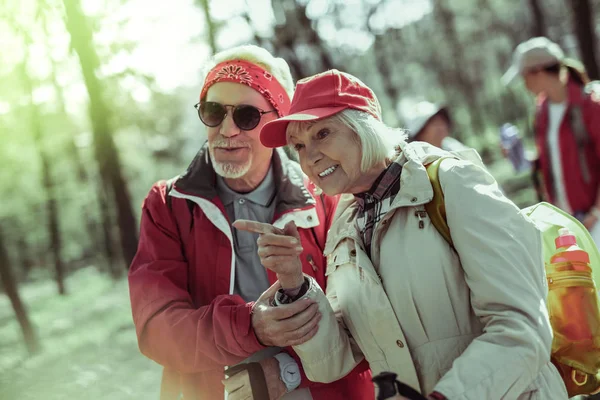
202, 44, 294, 100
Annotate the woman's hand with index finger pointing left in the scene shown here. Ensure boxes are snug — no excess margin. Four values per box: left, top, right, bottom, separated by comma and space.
233, 219, 304, 289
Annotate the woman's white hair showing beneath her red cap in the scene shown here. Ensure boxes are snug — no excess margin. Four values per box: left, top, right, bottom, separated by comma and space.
286, 108, 407, 172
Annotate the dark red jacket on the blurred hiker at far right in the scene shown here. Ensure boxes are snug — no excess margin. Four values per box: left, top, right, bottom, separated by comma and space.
535, 77, 600, 212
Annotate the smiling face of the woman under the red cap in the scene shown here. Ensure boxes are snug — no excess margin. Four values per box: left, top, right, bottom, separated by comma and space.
288, 118, 372, 196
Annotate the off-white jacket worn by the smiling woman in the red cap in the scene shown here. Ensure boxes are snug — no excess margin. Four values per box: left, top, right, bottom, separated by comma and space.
295, 142, 567, 400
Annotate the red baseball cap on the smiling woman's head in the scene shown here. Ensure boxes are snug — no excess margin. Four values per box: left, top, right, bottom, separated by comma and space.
260, 69, 381, 147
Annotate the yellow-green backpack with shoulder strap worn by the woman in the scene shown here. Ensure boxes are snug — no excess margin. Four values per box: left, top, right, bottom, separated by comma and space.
425, 153, 600, 397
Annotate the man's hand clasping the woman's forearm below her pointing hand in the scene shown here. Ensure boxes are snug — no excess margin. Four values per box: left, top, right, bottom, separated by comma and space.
252, 282, 321, 347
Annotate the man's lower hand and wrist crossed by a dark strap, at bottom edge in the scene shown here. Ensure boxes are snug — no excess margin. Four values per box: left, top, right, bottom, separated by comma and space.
223, 357, 287, 400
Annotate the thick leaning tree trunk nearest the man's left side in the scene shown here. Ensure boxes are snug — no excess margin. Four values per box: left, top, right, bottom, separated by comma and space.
63, 0, 137, 268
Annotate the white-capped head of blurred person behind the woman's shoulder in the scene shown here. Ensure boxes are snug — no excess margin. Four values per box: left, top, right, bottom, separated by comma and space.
407, 101, 468, 151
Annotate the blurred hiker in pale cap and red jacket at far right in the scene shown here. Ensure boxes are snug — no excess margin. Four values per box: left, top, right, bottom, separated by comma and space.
502, 37, 600, 246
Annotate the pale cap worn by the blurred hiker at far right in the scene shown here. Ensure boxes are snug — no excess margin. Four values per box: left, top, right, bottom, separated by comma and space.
502, 36, 565, 85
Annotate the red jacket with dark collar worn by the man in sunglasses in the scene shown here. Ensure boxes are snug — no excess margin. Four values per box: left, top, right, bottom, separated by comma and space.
129, 147, 374, 400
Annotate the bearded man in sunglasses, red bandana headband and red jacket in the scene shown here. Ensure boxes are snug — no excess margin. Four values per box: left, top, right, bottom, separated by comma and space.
129, 46, 374, 400
